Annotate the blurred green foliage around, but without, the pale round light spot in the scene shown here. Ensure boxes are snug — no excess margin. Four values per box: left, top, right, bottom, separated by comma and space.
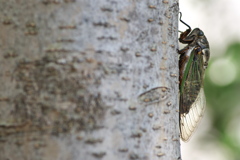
204, 42, 240, 160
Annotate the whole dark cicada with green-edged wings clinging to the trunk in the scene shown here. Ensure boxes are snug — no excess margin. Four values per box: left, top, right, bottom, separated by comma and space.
178, 12, 210, 141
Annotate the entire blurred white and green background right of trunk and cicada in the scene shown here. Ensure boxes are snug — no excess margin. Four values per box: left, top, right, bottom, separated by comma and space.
179, 0, 240, 160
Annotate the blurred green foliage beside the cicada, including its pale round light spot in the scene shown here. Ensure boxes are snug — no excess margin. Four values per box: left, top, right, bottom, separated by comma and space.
201, 42, 240, 160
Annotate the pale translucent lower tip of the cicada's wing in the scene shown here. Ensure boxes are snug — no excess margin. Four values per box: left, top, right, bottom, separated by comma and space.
180, 88, 206, 141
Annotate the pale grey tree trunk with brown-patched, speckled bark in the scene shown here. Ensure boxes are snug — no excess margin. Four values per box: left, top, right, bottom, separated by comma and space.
0, 0, 180, 160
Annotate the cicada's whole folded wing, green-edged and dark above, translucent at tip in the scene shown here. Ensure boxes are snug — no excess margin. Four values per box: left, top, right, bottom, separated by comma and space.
179, 47, 206, 141
